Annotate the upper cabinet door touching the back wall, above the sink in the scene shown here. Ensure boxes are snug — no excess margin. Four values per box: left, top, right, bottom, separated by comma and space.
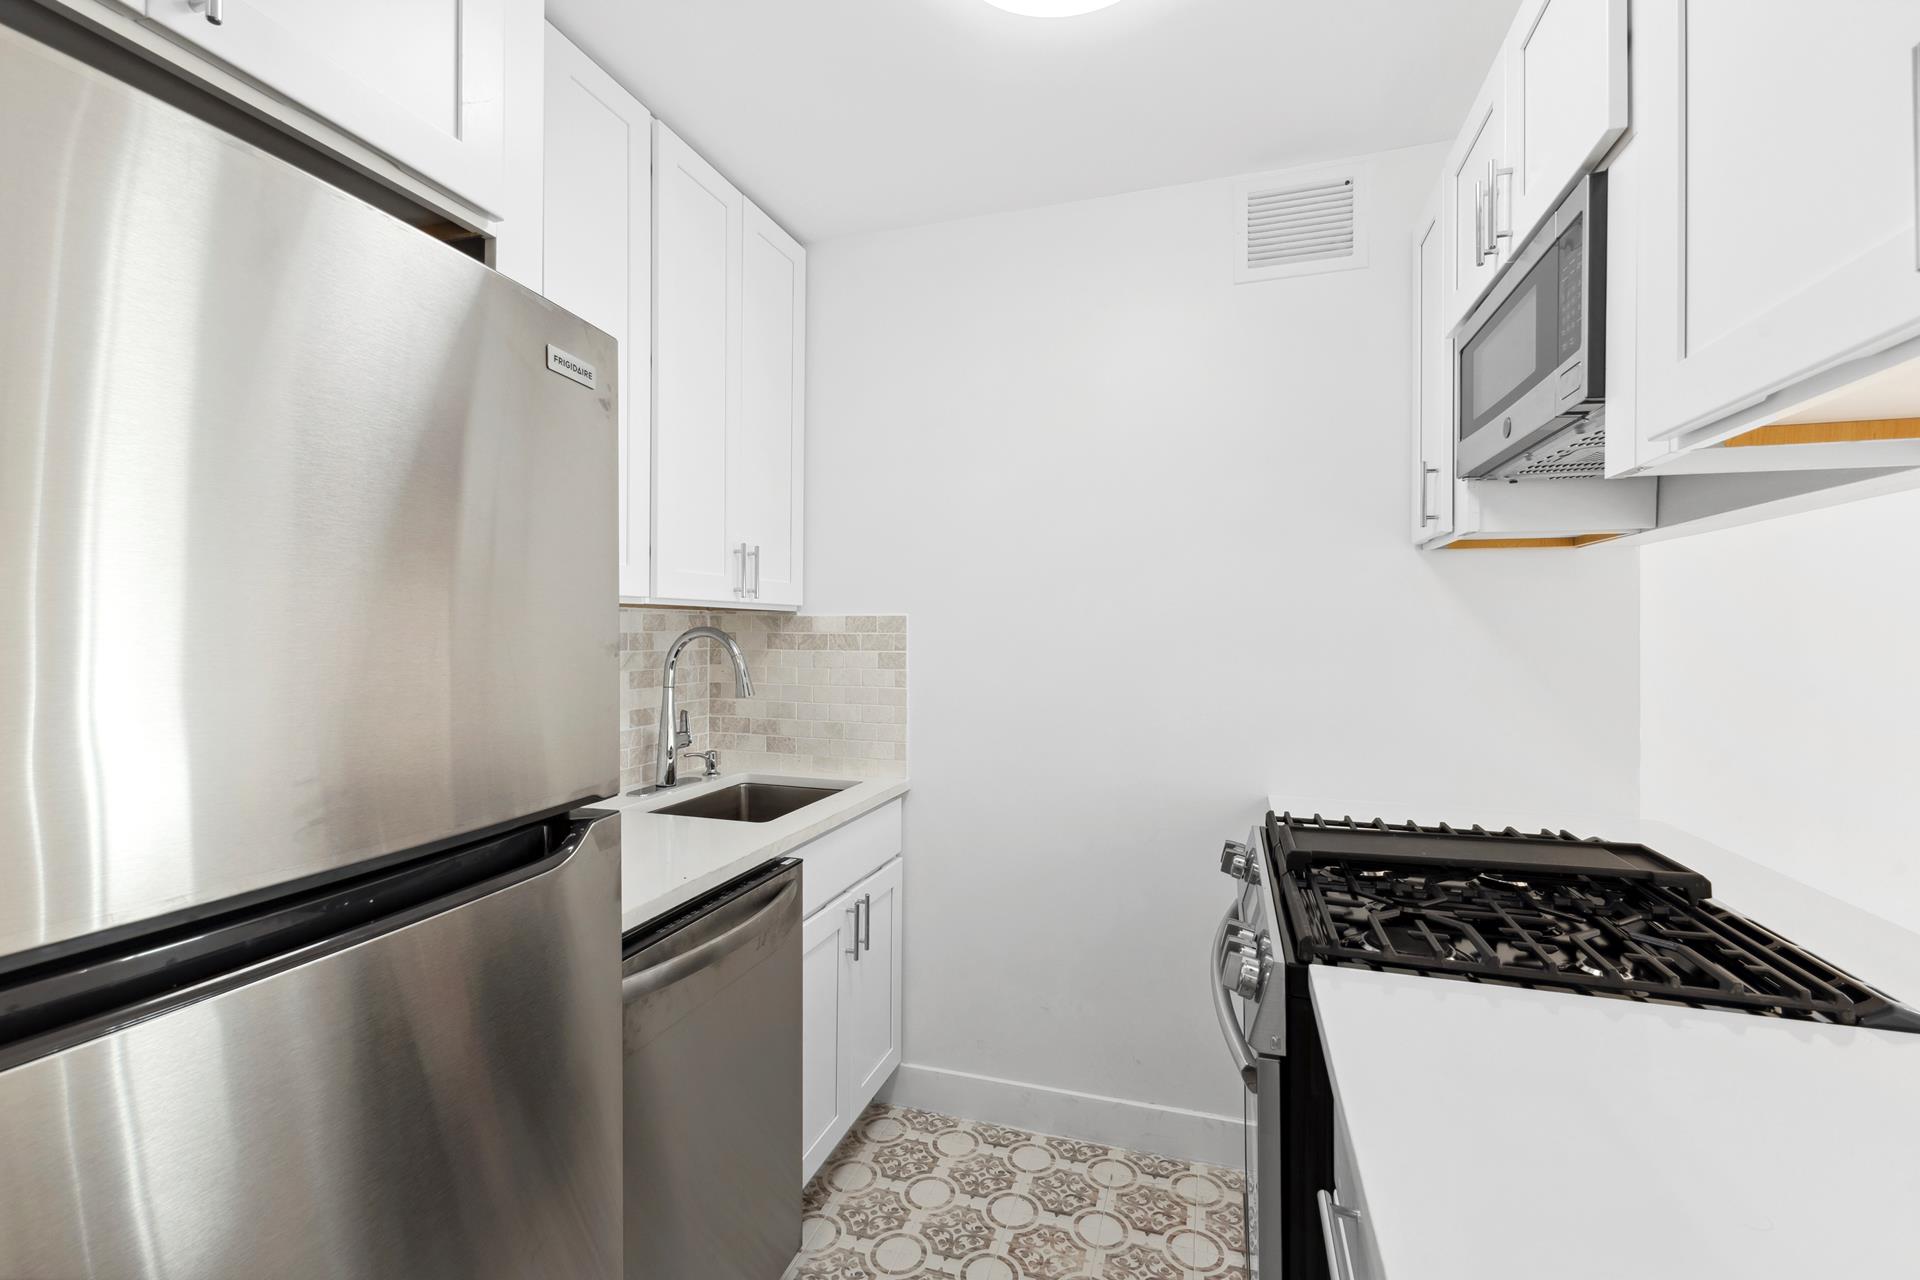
726, 201, 806, 608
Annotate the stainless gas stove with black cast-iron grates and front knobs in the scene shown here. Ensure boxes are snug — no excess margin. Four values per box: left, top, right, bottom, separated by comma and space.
1212, 814, 1920, 1280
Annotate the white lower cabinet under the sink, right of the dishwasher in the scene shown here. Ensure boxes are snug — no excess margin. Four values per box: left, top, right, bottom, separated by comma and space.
801, 800, 902, 1182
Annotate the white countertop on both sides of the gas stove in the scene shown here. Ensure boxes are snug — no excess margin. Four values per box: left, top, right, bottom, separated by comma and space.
1273, 796, 1920, 1280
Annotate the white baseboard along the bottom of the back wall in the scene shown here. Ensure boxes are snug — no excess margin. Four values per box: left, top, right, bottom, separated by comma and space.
879, 1063, 1246, 1167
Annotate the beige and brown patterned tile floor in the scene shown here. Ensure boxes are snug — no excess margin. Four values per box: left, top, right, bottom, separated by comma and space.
787, 1103, 1246, 1280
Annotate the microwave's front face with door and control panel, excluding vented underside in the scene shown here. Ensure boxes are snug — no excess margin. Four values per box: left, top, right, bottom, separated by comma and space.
1455, 177, 1605, 478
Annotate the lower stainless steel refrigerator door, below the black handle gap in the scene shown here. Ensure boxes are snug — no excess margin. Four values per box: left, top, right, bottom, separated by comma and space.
0, 816, 620, 1280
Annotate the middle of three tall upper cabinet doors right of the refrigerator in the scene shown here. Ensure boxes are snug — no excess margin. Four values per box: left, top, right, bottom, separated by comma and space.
653, 121, 745, 603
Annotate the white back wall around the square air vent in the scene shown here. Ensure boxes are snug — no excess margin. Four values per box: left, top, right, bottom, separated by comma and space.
806, 148, 1638, 1157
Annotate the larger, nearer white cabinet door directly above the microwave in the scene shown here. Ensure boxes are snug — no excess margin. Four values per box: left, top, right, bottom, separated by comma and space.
1505, 0, 1626, 244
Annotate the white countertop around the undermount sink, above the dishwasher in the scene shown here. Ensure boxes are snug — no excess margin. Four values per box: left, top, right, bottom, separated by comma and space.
591, 773, 906, 933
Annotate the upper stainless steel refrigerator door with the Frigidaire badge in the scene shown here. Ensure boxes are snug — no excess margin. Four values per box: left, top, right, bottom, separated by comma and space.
0, 27, 618, 967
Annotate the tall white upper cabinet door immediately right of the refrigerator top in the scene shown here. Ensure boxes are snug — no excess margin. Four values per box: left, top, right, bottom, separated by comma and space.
543, 27, 653, 599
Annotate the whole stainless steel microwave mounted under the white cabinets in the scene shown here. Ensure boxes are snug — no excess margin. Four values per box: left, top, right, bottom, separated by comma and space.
1453, 173, 1607, 480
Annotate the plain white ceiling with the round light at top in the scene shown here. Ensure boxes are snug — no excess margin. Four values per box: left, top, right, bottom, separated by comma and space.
547, 0, 1517, 242
